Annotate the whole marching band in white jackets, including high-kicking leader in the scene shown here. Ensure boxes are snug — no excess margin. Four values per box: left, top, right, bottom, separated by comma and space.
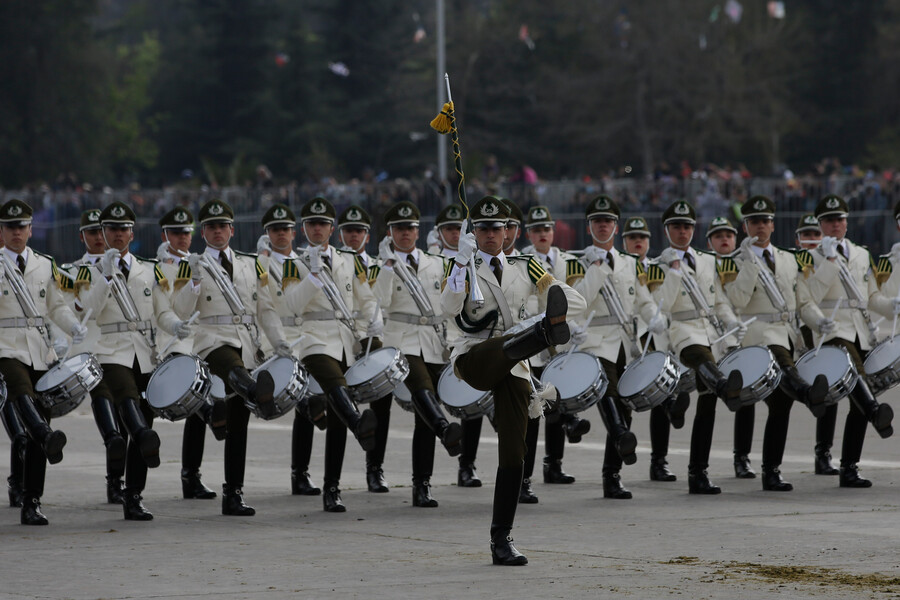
0, 195, 900, 565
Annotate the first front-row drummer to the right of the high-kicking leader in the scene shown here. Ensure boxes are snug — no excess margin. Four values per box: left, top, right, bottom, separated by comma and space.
567, 195, 665, 500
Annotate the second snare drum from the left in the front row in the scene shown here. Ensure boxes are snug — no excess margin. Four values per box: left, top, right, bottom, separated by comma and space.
145, 354, 213, 421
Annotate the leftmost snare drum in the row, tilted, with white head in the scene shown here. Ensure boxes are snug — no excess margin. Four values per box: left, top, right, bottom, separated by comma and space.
34, 352, 103, 419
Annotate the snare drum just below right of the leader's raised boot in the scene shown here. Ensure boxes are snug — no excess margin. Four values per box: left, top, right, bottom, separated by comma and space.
541, 352, 609, 415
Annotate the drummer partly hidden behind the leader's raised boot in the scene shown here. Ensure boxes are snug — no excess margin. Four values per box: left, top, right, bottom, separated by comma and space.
507, 202, 591, 502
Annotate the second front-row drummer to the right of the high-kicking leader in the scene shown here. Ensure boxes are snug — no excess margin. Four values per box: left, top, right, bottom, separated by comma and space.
647, 200, 744, 494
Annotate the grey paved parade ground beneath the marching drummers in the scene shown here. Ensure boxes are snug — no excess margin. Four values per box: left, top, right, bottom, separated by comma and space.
0, 391, 900, 599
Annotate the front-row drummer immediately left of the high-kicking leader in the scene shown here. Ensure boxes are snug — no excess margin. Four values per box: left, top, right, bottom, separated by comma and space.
372, 201, 462, 507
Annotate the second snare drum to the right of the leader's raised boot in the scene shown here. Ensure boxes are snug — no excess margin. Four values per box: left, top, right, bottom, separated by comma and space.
618, 350, 682, 412
